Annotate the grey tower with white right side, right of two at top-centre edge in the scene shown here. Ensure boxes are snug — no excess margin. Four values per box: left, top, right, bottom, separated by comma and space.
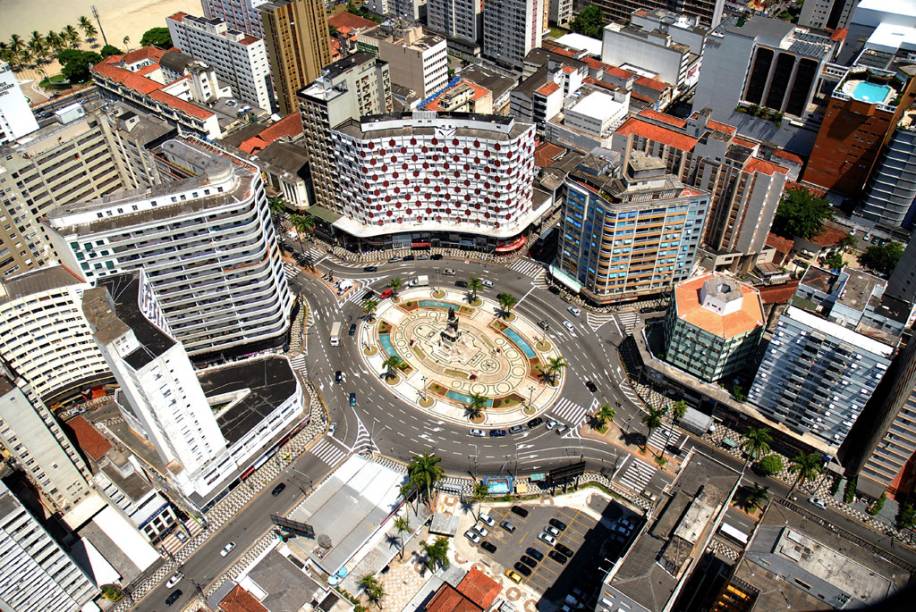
483, 0, 545, 71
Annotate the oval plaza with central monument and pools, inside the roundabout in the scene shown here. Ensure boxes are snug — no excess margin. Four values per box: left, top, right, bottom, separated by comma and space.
359, 287, 565, 428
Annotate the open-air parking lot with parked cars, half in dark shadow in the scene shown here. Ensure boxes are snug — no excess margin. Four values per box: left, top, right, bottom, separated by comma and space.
468, 495, 639, 607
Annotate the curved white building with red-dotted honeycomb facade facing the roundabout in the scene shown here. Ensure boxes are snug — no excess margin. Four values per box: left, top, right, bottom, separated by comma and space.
331, 112, 543, 238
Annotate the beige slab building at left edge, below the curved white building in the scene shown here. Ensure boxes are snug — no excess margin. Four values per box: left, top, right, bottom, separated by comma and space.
0, 361, 92, 514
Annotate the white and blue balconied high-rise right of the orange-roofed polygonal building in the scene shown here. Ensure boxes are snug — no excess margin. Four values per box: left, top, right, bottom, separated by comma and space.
748, 266, 910, 446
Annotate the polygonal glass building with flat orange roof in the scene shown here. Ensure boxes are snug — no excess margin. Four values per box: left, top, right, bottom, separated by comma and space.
665, 273, 766, 383
